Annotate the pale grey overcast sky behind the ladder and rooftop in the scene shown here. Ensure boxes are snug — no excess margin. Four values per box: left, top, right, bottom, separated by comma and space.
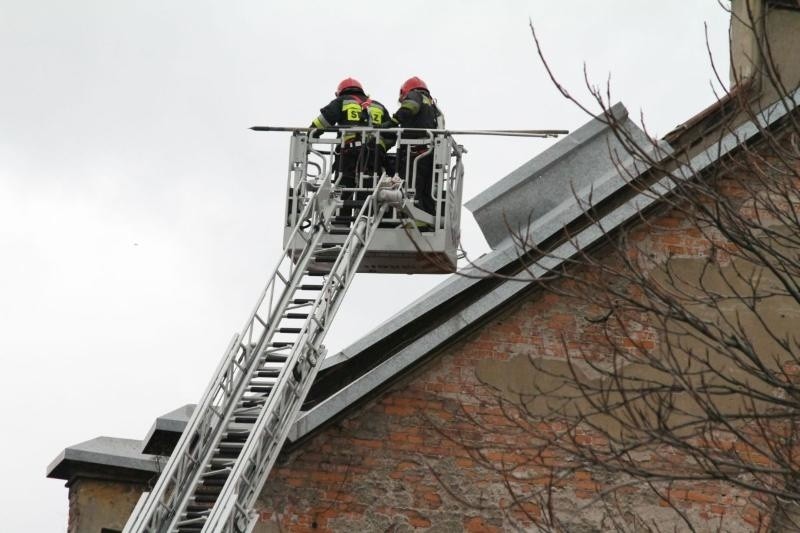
0, 0, 728, 532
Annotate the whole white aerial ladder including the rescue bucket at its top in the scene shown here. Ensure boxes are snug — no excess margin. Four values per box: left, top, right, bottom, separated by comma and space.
123, 122, 561, 533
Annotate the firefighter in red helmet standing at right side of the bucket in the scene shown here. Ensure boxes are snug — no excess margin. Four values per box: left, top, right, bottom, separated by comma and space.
392, 76, 444, 214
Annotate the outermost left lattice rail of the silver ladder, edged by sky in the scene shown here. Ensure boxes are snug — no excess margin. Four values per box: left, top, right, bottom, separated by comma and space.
126, 183, 324, 532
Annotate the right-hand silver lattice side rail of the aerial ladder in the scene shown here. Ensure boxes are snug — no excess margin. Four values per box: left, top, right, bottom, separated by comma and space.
203, 193, 386, 533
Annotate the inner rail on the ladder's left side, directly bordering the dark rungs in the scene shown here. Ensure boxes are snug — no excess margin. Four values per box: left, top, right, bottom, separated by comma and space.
166, 187, 336, 531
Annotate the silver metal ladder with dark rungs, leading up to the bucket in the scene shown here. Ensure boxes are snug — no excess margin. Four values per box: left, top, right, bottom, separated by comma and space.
124, 175, 401, 533
